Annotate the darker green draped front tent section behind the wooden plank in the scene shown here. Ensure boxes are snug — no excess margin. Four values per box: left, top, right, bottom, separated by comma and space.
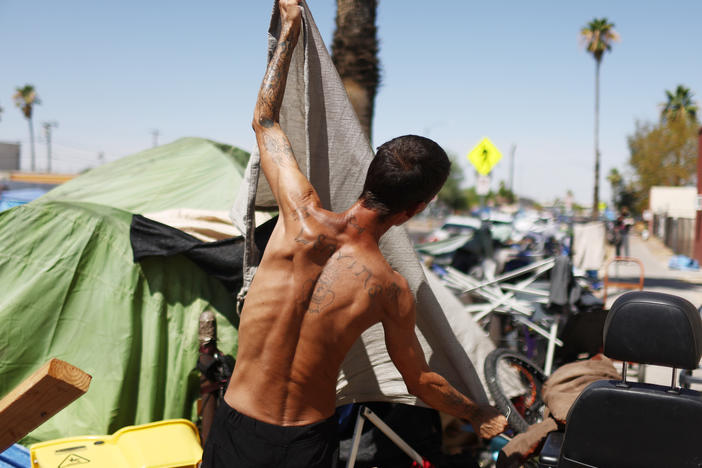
0, 202, 238, 443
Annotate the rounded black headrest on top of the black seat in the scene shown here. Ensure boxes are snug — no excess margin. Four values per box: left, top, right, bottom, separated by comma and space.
604, 291, 702, 369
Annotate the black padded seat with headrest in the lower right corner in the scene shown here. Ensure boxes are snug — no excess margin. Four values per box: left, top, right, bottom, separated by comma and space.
540, 291, 702, 468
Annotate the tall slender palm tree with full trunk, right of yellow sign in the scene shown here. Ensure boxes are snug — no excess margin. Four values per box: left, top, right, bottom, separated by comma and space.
580, 18, 619, 217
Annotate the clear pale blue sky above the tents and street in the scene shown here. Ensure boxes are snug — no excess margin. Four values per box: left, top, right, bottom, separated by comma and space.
0, 0, 702, 203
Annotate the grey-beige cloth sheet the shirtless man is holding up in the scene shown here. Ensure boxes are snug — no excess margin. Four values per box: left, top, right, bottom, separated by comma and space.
231, 1, 492, 404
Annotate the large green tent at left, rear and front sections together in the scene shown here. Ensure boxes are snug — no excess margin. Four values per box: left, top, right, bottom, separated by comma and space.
0, 138, 248, 443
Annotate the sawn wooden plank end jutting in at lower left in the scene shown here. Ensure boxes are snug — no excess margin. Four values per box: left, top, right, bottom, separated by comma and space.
0, 358, 92, 453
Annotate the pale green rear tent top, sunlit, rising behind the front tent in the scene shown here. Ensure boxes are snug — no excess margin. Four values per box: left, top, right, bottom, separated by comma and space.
38, 138, 249, 214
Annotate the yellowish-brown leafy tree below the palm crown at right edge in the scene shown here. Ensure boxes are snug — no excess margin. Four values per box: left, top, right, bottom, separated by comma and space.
628, 119, 697, 211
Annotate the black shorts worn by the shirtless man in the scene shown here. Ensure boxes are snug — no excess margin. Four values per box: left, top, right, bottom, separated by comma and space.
201, 401, 339, 468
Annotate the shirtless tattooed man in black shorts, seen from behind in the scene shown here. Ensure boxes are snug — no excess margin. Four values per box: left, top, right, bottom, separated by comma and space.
202, 0, 506, 468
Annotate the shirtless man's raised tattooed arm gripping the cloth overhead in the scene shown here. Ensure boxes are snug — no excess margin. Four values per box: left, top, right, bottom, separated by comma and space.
252, 0, 317, 214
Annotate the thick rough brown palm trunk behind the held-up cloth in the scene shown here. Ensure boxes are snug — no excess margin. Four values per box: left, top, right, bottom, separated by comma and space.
332, 0, 380, 141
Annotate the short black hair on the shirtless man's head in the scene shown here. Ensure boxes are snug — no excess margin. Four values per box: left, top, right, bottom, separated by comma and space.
360, 135, 451, 215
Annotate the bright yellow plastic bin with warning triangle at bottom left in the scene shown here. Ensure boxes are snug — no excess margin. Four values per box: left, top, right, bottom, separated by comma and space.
29, 419, 202, 468
